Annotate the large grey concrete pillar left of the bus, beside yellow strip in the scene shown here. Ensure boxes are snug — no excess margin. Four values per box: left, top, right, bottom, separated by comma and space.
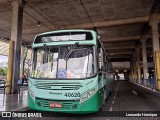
10, 0, 24, 93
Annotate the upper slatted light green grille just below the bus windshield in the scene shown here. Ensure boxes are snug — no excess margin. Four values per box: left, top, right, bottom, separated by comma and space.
34, 83, 82, 90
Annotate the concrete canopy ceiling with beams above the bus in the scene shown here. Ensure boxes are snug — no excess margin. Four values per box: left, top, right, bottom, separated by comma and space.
0, 0, 159, 61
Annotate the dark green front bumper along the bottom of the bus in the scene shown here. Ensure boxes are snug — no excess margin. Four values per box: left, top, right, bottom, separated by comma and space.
28, 92, 99, 114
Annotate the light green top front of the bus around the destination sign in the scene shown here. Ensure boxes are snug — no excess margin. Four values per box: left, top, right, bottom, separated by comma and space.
32, 29, 97, 47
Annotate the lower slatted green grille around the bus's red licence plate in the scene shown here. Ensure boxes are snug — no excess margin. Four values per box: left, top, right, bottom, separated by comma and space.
35, 98, 79, 109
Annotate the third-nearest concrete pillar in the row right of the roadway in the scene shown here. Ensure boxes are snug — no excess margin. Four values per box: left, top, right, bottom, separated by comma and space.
136, 46, 141, 84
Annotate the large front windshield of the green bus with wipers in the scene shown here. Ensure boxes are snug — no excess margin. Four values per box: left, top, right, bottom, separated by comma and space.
32, 45, 96, 79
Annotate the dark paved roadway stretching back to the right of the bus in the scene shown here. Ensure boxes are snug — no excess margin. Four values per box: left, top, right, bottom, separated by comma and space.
106, 81, 160, 111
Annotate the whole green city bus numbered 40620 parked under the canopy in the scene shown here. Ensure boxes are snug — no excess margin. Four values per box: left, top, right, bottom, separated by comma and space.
28, 29, 113, 113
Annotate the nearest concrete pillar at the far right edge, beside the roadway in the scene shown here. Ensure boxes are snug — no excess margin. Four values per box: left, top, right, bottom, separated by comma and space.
150, 13, 159, 88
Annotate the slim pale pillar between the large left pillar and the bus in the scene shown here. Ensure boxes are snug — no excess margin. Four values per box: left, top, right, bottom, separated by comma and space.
20, 45, 25, 77
